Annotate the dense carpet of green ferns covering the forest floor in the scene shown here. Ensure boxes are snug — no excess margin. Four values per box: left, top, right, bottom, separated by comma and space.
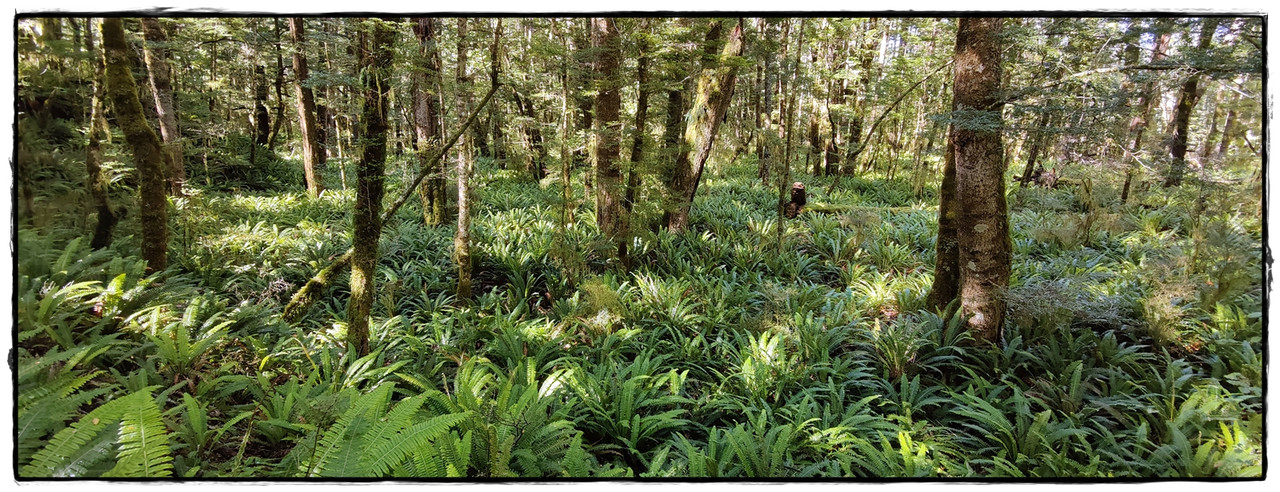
18, 153, 1263, 478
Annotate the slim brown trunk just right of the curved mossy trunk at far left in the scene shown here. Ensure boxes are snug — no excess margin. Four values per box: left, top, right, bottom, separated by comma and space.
142, 17, 187, 195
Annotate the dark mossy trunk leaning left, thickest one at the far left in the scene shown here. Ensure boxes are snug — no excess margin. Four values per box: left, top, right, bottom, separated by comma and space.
102, 18, 169, 272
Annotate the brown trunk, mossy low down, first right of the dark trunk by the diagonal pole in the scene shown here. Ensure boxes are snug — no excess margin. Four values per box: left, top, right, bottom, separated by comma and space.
411, 17, 447, 226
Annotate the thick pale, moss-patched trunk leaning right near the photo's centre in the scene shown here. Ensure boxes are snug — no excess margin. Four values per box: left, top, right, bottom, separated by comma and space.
667, 23, 742, 232
